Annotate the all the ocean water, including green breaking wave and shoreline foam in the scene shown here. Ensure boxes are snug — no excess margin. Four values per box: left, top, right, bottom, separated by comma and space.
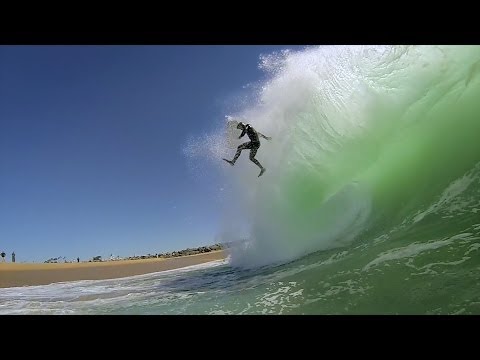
0, 46, 480, 314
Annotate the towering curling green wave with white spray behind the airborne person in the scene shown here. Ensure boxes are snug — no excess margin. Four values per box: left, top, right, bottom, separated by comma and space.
185, 45, 480, 266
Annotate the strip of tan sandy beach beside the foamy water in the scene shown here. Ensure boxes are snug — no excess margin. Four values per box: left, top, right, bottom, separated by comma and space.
0, 250, 227, 288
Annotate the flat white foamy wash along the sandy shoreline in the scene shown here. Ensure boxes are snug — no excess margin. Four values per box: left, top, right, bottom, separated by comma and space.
0, 260, 227, 314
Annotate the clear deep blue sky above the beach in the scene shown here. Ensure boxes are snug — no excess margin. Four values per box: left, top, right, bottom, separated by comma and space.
0, 45, 300, 262
